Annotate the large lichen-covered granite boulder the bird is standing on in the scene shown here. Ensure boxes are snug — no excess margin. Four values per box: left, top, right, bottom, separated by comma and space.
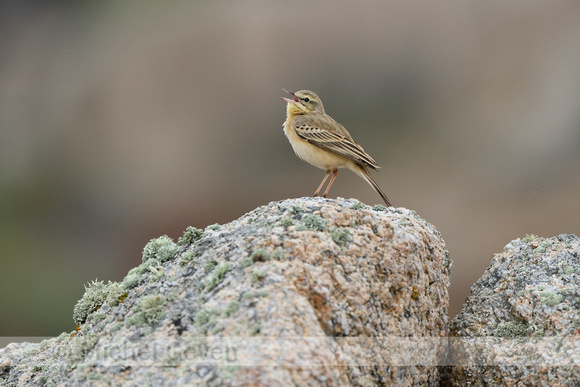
0, 198, 450, 386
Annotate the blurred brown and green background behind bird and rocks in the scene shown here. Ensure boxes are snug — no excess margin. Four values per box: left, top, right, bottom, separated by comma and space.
0, 0, 580, 336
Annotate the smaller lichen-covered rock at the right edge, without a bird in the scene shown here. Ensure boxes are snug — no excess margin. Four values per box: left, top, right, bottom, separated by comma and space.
447, 235, 580, 386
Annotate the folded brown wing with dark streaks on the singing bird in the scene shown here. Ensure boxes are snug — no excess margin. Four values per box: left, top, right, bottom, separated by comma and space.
294, 123, 380, 169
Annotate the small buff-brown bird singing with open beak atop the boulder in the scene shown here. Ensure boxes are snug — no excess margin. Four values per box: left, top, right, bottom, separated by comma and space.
282, 89, 392, 207
